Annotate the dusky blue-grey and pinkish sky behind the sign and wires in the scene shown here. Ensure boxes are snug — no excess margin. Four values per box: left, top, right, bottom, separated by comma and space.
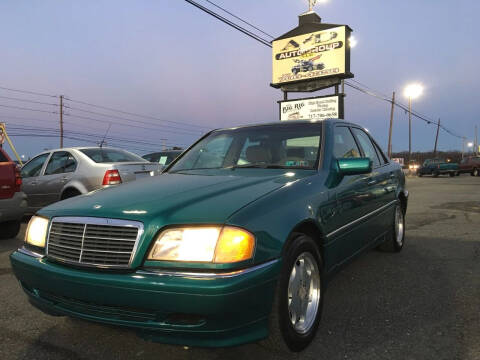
0, 0, 480, 157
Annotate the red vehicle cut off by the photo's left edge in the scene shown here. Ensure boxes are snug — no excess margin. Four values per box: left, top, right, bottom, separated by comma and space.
0, 148, 27, 239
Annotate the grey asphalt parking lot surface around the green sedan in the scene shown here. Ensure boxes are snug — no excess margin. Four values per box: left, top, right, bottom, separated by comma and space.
0, 175, 480, 360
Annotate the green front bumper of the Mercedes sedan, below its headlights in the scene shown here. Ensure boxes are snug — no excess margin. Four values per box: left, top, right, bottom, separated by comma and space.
10, 250, 281, 347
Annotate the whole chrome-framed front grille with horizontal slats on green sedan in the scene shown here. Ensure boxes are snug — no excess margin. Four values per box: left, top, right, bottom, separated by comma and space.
47, 217, 143, 268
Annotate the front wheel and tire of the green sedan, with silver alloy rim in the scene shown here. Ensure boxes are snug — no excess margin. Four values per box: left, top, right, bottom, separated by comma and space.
264, 233, 324, 352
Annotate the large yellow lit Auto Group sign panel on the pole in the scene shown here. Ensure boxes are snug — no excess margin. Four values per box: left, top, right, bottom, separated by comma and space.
272, 25, 352, 87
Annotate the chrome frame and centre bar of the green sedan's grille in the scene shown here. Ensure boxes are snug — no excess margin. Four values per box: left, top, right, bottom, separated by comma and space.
45, 216, 144, 269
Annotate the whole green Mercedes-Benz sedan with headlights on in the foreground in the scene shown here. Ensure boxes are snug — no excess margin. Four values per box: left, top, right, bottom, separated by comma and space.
11, 120, 408, 351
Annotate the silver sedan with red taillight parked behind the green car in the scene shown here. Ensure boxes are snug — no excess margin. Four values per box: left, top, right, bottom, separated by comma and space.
22, 147, 159, 213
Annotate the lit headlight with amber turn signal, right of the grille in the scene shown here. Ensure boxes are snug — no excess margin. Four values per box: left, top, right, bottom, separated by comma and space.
148, 226, 255, 264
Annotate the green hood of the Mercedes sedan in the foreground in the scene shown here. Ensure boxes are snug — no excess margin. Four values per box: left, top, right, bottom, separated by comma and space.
39, 169, 314, 226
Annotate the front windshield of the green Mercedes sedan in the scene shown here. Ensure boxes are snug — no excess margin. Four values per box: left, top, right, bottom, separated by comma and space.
169, 123, 321, 172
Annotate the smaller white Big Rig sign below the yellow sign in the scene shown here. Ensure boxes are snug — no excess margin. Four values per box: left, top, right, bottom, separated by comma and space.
278, 95, 343, 121
